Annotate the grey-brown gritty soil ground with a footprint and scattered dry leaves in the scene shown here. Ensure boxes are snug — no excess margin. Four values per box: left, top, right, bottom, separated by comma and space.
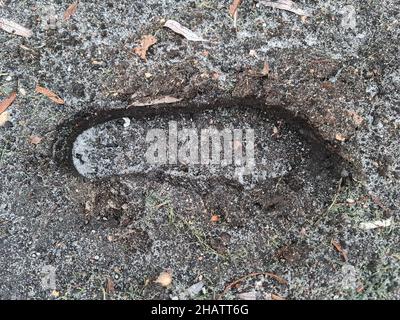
0, 0, 400, 299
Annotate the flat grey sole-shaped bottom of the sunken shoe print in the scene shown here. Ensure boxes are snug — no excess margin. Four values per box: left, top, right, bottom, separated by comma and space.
73, 108, 338, 189
